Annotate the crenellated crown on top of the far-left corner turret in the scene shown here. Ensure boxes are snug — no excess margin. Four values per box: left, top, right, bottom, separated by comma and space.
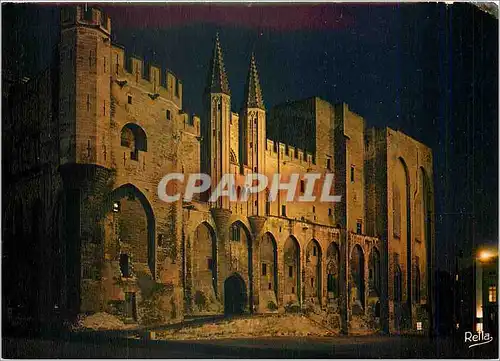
61, 5, 111, 35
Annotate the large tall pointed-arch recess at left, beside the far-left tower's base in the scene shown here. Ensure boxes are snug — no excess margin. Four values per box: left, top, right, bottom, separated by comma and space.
101, 183, 156, 321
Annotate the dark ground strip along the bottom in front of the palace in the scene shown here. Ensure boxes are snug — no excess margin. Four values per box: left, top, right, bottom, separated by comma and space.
2, 332, 498, 358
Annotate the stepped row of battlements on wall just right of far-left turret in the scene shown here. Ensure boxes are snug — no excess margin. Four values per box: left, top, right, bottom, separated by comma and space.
111, 44, 182, 109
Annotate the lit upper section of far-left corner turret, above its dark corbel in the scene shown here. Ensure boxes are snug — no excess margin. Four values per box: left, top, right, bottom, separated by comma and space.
59, 6, 111, 167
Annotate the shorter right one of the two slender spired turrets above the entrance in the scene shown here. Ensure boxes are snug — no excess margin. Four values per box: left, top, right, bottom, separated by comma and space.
240, 53, 266, 216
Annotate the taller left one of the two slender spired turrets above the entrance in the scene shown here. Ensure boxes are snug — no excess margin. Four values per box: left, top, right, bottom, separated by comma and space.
201, 34, 231, 209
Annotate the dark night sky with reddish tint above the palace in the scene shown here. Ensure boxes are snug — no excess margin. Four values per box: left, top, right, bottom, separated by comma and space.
2, 3, 498, 269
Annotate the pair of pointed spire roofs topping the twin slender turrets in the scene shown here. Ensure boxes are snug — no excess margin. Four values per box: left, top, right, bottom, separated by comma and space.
207, 33, 265, 110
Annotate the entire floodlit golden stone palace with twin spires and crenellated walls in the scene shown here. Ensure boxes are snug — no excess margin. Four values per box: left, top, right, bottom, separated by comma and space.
2, 7, 434, 332
